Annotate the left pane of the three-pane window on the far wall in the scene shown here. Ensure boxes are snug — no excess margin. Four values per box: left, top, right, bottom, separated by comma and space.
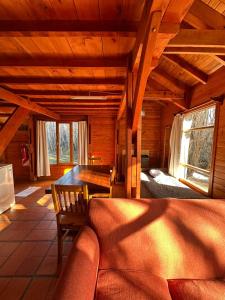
46, 122, 57, 164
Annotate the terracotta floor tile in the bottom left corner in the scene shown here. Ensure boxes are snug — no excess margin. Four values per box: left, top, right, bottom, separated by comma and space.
0, 278, 30, 300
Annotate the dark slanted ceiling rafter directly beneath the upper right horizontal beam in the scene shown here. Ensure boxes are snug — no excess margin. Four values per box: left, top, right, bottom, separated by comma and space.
163, 54, 208, 84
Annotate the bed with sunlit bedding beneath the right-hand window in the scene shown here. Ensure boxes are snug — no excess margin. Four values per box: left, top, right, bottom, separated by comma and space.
141, 169, 207, 199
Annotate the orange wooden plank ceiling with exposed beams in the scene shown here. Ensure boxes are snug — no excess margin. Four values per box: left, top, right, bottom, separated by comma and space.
0, 0, 225, 122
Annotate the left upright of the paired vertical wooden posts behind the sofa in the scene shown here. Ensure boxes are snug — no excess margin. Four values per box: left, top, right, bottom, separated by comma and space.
126, 71, 133, 198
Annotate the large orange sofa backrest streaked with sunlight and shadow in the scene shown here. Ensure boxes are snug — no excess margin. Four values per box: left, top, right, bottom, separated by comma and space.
89, 198, 225, 279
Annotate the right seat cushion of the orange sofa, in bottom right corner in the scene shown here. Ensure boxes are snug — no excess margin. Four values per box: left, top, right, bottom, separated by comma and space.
168, 279, 225, 300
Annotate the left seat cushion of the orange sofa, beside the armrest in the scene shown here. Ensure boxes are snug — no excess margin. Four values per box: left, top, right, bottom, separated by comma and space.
95, 270, 171, 300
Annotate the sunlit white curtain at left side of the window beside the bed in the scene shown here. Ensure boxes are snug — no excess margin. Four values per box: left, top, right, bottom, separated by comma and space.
169, 114, 183, 178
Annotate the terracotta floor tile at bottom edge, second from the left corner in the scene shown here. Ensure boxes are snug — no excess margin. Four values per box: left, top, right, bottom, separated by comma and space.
23, 278, 56, 300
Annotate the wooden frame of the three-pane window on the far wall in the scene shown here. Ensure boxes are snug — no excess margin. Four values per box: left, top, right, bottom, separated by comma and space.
46, 121, 79, 166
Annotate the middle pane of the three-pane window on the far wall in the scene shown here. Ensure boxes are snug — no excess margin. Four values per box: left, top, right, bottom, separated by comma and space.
59, 123, 70, 163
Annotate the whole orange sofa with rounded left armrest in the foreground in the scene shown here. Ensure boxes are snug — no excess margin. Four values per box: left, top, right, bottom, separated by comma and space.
55, 199, 225, 300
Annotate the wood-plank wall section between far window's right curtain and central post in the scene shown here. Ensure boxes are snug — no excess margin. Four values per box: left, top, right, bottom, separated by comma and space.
89, 116, 116, 165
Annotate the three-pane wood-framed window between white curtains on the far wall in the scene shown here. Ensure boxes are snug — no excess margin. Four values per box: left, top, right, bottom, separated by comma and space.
46, 122, 78, 164
